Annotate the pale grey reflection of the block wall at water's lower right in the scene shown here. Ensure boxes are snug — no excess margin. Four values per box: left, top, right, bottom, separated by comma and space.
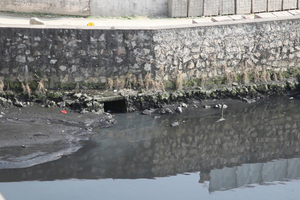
209, 158, 300, 192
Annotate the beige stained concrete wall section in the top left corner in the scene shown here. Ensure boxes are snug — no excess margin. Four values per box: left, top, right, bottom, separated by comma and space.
0, 0, 90, 16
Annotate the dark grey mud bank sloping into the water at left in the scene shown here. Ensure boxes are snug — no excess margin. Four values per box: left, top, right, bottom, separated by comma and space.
0, 105, 115, 169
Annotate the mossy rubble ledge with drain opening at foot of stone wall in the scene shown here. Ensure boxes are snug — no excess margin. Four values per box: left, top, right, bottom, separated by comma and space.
0, 76, 300, 114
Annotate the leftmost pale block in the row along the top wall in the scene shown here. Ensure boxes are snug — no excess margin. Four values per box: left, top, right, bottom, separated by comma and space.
168, 0, 188, 17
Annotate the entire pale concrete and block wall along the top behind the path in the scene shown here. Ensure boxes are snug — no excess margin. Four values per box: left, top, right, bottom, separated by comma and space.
0, 0, 300, 17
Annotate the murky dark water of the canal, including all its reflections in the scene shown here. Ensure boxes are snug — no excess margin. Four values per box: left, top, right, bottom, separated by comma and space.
0, 98, 300, 200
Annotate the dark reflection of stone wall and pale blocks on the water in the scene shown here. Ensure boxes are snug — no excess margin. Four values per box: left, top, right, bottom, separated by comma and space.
0, 98, 300, 191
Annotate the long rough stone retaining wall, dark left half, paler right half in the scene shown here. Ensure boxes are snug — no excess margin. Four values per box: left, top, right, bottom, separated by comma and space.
0, 16, 300, 89
